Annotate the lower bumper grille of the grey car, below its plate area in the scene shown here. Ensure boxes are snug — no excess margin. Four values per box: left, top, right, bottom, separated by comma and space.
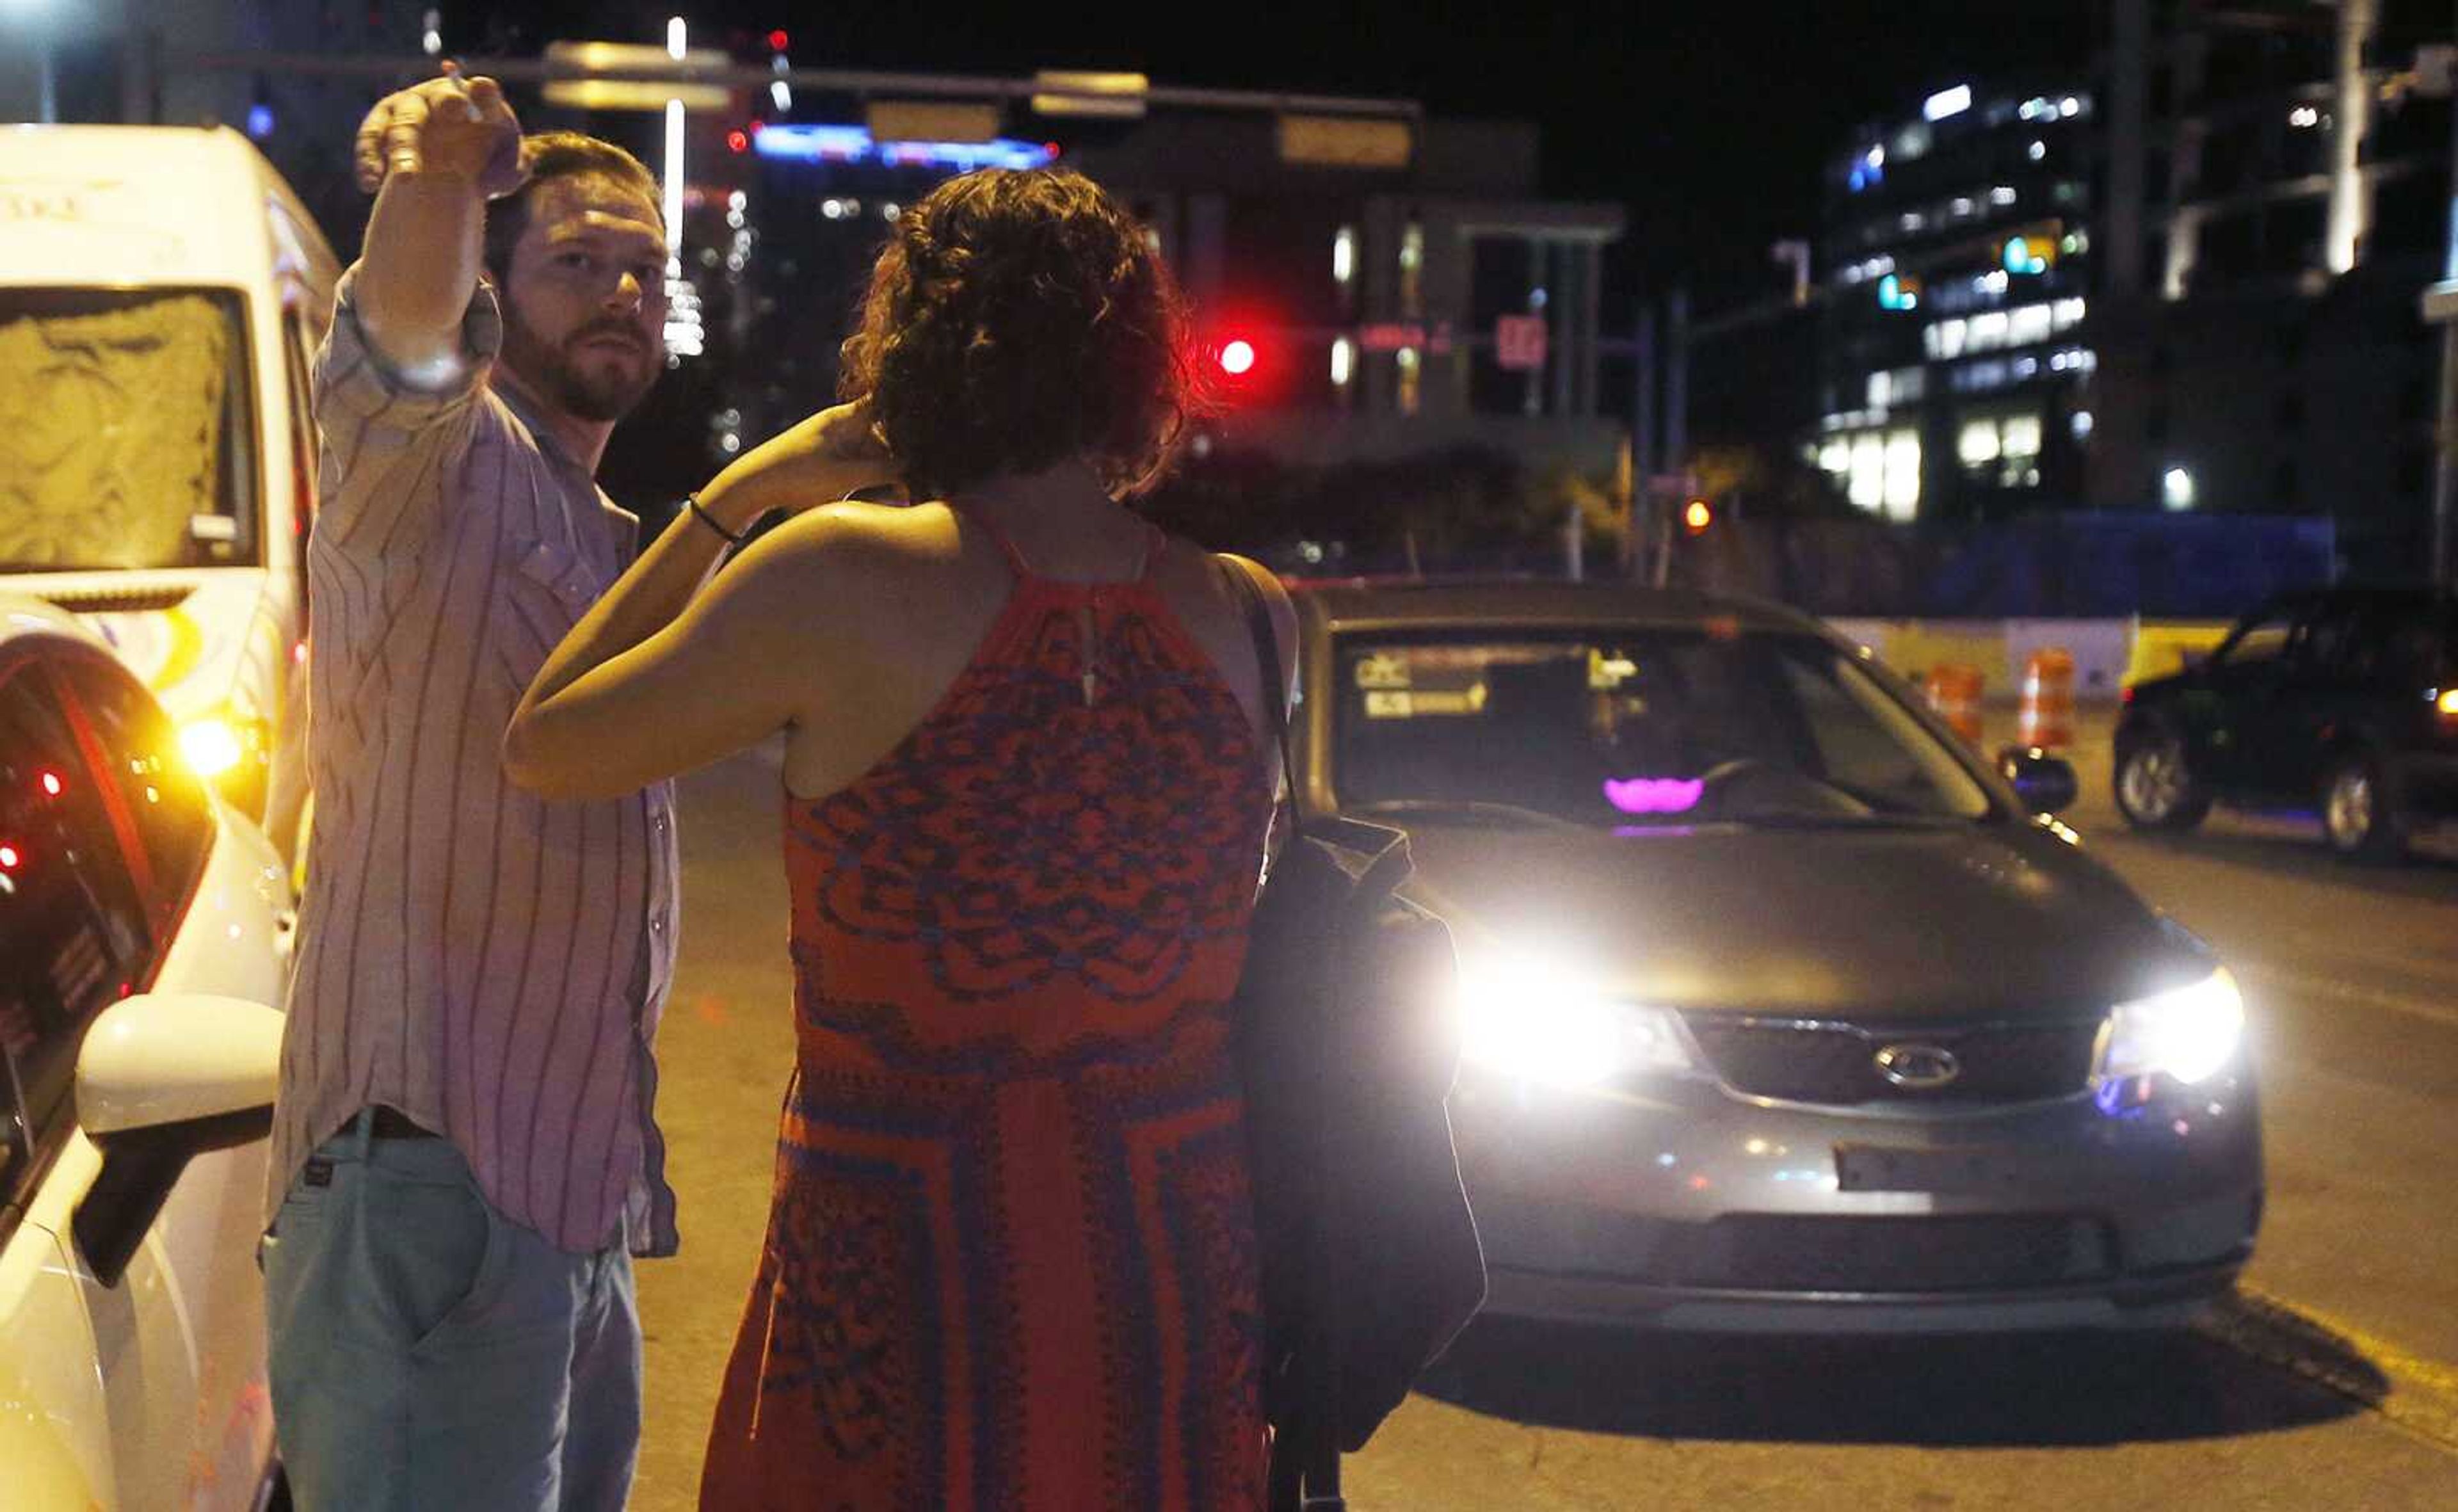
1657, 1212, 2116, 1291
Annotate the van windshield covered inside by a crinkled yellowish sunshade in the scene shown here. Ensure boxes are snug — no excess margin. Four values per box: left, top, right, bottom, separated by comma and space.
0, 287, 258, 573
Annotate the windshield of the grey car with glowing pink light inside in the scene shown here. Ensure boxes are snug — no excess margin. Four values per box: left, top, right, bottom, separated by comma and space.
1332, 625, 1993, 828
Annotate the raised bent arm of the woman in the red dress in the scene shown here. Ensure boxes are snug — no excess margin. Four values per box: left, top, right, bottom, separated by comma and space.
504, 406, 887, 799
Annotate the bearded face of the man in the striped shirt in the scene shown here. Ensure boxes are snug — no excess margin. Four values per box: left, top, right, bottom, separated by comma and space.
501, 175, 666, 421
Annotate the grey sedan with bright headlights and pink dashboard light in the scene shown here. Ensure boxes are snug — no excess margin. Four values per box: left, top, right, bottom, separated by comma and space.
1296, 583, 2264, 1333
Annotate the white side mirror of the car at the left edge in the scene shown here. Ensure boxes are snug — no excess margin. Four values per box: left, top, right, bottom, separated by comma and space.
74, 993, 283, 1286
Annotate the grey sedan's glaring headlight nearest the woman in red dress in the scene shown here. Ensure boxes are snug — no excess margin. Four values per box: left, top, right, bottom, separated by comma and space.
1460, 956, 1696, 1087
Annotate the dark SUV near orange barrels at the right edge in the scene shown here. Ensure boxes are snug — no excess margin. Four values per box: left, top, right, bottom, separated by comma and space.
2114, 588, 2458, 860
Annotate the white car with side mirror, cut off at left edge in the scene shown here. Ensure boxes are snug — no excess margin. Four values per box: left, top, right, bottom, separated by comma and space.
0, 593, 293, 1512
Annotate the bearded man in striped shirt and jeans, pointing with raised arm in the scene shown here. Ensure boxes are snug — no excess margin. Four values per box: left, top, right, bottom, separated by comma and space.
263, 71, 747, 1512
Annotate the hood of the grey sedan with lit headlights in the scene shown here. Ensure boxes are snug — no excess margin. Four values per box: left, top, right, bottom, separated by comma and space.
1411, 824, 2212, 1023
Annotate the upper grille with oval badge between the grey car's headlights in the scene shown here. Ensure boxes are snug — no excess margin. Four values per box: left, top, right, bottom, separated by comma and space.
1683, 1013, 2099, 1106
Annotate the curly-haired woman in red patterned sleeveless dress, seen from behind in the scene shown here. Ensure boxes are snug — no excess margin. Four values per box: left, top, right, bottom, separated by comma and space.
506, 170, 1296, 1512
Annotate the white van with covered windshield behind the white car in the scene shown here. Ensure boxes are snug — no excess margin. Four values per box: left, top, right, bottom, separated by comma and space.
0, 125, 342, 853
